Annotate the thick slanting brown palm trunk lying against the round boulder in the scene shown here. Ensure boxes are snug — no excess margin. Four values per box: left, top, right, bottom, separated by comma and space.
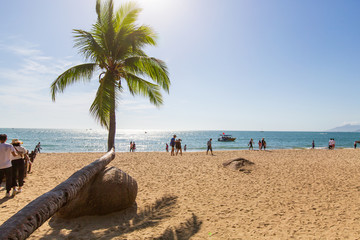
0, 149, 115, 240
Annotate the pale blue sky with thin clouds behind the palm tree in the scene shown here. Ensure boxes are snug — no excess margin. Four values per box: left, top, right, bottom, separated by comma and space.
0, 0, 360, 131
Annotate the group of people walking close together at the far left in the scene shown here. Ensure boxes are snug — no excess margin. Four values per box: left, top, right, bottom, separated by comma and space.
0, 134, 32, 197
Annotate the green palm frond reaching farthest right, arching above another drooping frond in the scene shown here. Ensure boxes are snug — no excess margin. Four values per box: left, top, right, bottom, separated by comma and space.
124, 56, 171, 92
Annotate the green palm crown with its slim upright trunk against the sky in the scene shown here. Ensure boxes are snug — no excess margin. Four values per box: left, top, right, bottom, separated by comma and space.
51, 0, 170, 150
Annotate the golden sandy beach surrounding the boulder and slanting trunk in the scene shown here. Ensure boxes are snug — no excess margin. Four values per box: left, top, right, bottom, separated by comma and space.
0, 149, 360, 239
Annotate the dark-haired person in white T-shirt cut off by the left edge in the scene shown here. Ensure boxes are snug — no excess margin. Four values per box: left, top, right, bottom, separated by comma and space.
0, 134, 17, 197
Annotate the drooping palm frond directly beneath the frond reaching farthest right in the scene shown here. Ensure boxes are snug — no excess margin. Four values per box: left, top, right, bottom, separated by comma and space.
125, 73, 163, 107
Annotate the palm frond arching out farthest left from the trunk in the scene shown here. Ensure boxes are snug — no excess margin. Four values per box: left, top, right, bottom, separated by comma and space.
50, 63, 97, 101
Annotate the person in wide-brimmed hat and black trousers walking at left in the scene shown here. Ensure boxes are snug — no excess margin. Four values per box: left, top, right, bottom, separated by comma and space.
10, 139, 30, 196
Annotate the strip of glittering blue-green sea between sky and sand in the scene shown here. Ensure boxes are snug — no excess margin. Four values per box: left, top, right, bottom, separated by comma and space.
0, 128, 360, 153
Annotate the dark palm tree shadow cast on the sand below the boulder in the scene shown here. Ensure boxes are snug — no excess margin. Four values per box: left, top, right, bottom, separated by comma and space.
41, 196, 201, 239
